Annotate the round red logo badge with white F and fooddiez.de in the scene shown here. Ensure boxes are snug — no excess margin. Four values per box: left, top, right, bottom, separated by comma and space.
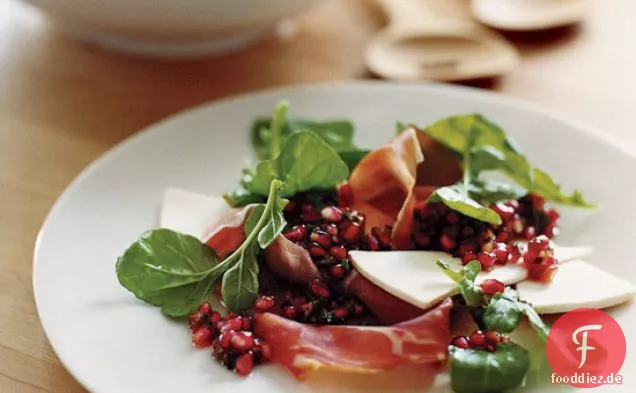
546, 308, 627, 388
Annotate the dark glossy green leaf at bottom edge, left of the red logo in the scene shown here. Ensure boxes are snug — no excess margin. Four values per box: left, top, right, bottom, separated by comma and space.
449, 342, 530, 393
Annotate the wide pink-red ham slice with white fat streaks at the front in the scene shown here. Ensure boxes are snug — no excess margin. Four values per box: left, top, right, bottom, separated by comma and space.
254, 299, 452, 379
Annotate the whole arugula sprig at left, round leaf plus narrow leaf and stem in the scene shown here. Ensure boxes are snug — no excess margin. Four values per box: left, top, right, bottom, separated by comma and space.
116, 180, 287, 316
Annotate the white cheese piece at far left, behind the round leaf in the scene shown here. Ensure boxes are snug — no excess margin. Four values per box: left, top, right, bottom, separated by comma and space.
159, 188, 230, 239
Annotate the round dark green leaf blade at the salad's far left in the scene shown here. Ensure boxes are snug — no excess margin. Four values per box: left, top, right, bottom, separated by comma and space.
116, 229, 218, 316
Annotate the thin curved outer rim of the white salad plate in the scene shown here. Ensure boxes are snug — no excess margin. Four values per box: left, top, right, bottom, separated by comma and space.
31, 80, 636, 391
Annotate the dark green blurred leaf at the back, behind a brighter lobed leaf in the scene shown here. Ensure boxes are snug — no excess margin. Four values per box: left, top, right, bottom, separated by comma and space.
251, 103, 370, 170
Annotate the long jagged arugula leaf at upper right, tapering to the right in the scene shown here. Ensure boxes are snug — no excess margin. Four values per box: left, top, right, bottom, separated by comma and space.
424, 114, 593, 207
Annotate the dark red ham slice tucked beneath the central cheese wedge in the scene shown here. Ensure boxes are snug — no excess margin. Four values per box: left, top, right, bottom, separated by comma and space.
343, 271, 426, 325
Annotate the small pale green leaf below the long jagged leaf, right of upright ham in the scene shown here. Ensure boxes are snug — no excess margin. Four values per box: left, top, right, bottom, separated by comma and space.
428, 184, 501, 225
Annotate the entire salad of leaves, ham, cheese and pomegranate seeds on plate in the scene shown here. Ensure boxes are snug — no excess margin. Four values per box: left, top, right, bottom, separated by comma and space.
116, 103, 635, 393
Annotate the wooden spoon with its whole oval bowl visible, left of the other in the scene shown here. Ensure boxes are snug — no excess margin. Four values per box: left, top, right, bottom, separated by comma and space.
366, 0, 518, 81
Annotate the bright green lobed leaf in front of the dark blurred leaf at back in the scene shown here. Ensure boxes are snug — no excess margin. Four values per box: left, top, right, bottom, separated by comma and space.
242, 131, 349, 196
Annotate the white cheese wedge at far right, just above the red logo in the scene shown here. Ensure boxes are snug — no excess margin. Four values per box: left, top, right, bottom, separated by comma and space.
517, 261, 636, 314
